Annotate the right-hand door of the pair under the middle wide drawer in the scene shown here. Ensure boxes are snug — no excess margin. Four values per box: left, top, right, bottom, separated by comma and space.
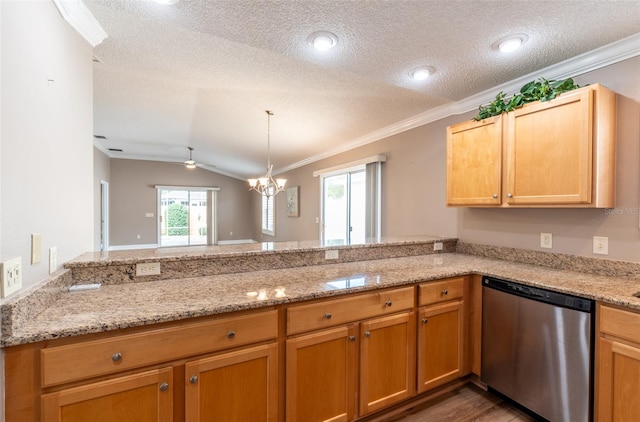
360, 312, 415, 416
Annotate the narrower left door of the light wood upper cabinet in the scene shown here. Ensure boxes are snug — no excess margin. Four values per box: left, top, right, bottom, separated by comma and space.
447, 116, 503, 205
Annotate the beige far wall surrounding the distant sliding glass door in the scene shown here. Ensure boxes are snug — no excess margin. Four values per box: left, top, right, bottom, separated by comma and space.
109, 159, 257, 246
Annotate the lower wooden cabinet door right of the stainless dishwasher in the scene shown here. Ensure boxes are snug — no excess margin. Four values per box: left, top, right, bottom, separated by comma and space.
596, 338, 640, 422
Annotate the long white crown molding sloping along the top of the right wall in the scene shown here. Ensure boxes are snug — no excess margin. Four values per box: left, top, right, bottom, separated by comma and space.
274, 32, 640, 175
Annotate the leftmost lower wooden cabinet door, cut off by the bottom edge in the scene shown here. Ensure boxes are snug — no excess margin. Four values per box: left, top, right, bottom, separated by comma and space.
42, 368, 173, 422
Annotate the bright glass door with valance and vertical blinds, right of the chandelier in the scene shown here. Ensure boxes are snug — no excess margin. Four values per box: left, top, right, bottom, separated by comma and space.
313, 155, 386, 246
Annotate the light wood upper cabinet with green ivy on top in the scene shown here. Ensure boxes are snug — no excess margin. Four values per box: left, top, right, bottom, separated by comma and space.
447, 84, 616, 208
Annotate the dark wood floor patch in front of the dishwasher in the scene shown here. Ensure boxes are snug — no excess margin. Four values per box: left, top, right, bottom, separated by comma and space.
384, 384, 535, 422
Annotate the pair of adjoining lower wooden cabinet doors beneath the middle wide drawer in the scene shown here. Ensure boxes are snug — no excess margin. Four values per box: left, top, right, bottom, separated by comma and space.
286, 312, 415, 422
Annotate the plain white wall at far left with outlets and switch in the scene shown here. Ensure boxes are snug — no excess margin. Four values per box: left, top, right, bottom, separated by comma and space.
0, 1, 93, 296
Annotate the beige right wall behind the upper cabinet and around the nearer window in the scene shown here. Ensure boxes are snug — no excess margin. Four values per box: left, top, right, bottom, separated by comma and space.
272, 57, 640, 262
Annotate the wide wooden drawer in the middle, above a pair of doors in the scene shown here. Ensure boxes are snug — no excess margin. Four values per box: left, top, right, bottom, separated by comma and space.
287, 287, 414, 335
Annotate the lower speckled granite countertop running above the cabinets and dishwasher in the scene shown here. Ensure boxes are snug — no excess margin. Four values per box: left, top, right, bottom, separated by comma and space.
1, 253, 640, 347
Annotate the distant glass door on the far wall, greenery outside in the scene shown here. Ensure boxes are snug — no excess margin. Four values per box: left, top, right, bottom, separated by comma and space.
156, 186, 218, 246
